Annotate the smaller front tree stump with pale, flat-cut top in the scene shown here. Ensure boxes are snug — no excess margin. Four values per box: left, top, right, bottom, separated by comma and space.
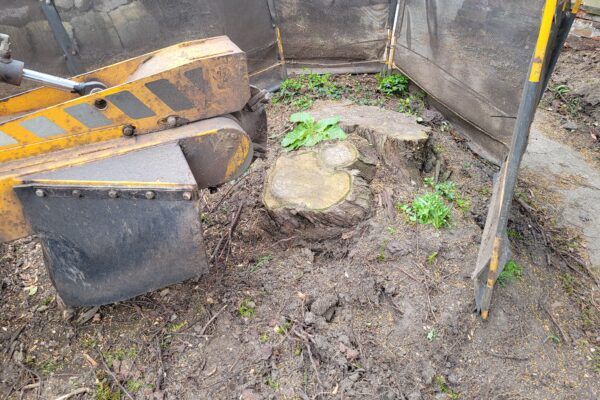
263, 137, 377, 239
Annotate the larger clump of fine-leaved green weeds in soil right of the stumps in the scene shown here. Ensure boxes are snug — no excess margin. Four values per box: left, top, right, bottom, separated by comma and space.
399, 193, 450, 229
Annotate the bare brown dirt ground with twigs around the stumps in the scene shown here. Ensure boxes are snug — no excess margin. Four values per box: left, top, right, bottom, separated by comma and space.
0, 35, 600, 400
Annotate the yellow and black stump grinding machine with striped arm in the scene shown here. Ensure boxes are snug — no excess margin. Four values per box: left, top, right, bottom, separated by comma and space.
0, 35, 267, 306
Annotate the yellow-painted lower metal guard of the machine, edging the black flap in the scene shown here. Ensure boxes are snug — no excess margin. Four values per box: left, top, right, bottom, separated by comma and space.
0, 118, 252, 242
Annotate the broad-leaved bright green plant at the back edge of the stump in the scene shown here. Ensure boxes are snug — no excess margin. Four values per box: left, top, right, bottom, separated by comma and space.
281, 112, 346, 151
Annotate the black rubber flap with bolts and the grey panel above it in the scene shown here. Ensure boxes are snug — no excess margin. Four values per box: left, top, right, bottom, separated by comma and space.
15, 144, 208, 306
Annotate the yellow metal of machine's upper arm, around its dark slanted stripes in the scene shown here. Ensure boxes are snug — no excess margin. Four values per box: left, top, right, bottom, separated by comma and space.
0, 36, 250, 162
